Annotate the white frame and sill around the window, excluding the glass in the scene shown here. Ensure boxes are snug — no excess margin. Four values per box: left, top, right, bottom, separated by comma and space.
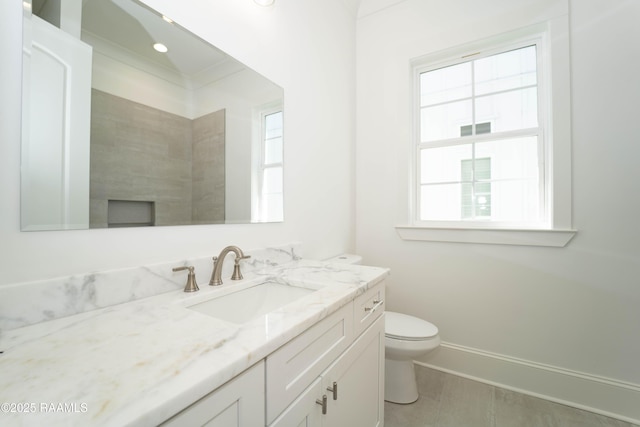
396, 17, 576, 247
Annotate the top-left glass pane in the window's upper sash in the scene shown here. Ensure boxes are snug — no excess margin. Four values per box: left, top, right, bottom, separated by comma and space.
420, 62, 471, 106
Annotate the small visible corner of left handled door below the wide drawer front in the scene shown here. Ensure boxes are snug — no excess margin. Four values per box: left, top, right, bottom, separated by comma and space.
270, 378, 326, 427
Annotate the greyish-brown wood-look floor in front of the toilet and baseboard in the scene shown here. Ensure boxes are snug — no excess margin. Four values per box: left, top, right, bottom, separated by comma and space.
384, 365, 640, 427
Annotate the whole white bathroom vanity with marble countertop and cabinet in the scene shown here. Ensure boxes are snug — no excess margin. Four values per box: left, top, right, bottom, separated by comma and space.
0, 249, 388, 427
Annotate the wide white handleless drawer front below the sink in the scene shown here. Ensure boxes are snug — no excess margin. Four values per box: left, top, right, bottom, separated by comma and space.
266, 303, 354, 424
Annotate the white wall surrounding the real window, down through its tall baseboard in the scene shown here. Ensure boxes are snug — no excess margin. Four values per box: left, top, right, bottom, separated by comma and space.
356, 0, 640, 420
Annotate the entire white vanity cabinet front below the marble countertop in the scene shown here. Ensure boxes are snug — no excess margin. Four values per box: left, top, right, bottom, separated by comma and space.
162, 283, 384, 427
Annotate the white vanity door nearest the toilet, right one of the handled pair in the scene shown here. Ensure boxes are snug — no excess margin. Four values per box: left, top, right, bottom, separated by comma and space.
322, 315, 384, 427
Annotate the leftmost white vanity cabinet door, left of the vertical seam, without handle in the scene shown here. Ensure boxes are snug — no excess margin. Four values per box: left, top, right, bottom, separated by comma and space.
162, 362, 264, 427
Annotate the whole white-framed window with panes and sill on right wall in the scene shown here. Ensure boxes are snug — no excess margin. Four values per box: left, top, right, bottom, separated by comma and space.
396, 23, 576, 247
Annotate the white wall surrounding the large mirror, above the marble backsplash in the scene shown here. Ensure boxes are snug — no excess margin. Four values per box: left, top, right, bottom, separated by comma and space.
0, 0, 355, 285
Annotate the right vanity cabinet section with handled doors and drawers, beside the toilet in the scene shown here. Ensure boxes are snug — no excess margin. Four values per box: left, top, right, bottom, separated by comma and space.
266, 284, 384, 427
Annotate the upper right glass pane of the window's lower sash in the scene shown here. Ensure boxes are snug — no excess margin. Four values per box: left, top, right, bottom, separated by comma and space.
476, 136, 539, 182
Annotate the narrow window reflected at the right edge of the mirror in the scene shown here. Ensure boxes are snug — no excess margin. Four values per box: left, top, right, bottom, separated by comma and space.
254, 107, 284, 222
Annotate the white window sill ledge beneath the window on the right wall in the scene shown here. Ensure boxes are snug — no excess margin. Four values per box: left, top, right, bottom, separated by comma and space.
396, 226, 577, 248
